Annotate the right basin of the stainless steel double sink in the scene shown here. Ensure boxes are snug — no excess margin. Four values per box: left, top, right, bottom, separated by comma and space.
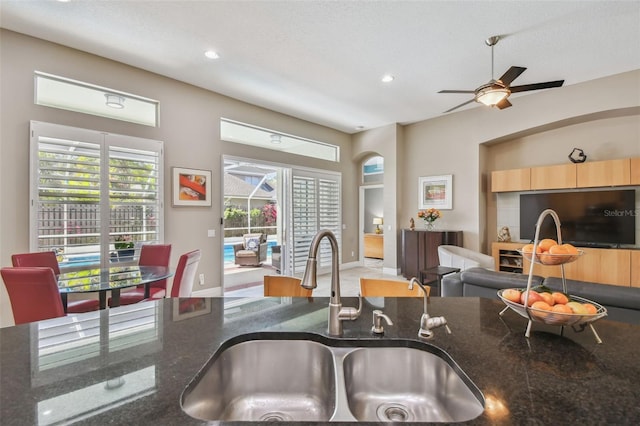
343, 347, 484, 422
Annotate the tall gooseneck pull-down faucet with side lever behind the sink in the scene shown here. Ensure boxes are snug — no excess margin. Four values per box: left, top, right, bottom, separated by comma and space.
300, 229, 362, 336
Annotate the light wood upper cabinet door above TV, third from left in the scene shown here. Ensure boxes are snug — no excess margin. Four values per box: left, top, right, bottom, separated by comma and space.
576, 158, 631, 188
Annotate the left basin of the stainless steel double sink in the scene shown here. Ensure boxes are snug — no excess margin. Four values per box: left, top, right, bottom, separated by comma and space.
182, 340, 336, 422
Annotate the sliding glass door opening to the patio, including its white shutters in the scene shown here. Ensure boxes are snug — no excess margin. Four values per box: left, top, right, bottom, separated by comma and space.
223, 157, 342, 296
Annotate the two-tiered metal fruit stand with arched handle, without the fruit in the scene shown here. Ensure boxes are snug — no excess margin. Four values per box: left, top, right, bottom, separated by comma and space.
498, 209, 607, 343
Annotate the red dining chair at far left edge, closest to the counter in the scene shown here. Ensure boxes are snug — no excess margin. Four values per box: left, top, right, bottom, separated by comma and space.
0, 267, 65, 324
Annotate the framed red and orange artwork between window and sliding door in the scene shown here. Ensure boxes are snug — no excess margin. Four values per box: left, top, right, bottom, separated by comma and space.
171, 167, 211, 206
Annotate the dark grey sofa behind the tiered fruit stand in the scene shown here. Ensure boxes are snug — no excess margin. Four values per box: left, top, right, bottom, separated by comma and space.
441, 268, 640, 325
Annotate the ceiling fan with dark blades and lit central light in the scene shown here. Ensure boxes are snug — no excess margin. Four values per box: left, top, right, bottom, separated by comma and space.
438, 36, 564, 113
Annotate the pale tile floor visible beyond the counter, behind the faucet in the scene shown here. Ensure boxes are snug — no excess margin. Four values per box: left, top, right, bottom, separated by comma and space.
225, 258, 405, 297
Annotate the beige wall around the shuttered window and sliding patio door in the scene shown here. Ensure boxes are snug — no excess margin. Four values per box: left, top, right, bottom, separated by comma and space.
0, 30, 358, 326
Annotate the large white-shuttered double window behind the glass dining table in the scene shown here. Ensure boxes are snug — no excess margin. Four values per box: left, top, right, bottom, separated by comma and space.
30, 121, 163, 268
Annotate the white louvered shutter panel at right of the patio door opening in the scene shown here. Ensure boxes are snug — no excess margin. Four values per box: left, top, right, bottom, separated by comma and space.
287, 170, 342, 275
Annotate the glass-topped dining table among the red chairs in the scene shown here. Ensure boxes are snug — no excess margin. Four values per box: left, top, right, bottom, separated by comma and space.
58, 265, 173, 312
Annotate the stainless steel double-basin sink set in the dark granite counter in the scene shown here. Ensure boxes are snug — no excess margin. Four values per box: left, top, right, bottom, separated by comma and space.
181, 332, 484, 422
